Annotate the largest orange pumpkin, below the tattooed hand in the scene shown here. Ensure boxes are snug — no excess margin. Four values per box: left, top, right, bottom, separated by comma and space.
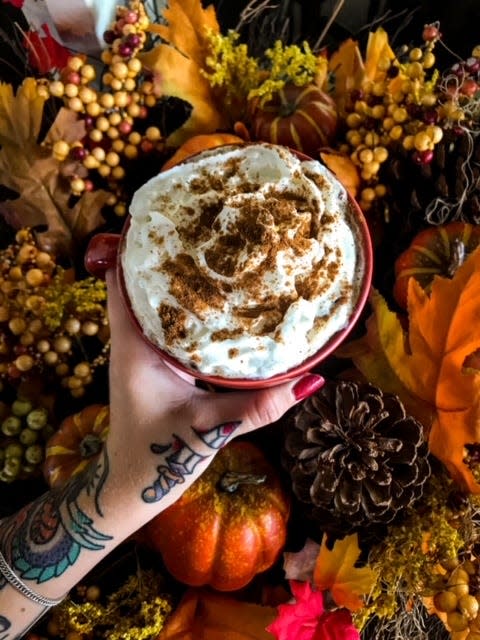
144, 441, 289, 591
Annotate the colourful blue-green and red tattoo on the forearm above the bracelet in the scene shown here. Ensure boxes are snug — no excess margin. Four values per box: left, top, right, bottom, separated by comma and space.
0, 449, 112, 588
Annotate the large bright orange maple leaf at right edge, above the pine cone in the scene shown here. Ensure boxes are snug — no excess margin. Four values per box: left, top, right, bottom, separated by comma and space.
343, 249, 480, 494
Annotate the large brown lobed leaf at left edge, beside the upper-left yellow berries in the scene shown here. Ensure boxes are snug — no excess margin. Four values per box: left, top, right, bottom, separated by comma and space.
0, 78, 108, 255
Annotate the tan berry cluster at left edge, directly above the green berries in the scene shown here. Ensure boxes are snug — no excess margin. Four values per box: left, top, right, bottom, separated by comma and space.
0, 229, 109, 397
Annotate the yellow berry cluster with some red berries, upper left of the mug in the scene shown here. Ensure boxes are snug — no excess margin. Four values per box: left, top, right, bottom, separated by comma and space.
49, 0, 163, 216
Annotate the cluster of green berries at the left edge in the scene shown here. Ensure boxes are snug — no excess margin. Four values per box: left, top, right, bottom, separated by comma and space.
0, 395, 54, 483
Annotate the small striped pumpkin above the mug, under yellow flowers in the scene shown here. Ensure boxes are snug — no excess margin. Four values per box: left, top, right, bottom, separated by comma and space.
249, 84, 338, 156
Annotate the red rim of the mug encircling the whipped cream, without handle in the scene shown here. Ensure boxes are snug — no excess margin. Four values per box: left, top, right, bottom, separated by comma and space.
116, 143, 373, 389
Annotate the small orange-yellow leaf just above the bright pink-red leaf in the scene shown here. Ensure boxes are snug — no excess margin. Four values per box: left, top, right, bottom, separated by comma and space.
313, 533, 377, 612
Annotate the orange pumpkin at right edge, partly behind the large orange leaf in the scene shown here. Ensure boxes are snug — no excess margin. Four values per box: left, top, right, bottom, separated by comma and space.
393, 222, 480, 309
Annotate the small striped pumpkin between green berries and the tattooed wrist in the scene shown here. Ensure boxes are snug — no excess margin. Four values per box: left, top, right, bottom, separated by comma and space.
43, 404, 110, 487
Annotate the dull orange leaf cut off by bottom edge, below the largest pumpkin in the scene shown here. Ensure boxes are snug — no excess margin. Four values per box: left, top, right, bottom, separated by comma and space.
156, 589, 277, 640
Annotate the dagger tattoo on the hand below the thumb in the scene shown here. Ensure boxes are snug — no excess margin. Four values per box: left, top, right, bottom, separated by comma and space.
142, 420, 241, 502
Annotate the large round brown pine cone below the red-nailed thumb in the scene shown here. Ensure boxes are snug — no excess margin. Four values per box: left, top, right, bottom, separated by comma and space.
283, 382, 430, 535
